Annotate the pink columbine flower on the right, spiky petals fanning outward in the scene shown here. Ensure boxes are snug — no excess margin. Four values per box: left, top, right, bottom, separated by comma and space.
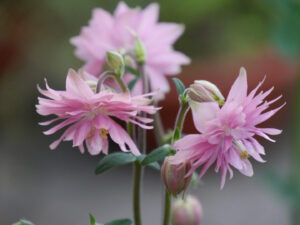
173, 68, 283, 189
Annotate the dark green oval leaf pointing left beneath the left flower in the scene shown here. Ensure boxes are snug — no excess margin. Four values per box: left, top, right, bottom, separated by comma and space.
95, 152, 136, 174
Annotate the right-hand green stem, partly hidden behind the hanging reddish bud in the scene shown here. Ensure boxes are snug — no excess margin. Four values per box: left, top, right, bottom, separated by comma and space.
163, 102, 190, 225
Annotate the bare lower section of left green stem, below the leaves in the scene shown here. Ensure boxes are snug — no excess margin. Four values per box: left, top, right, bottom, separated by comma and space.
133, 162, 142, 225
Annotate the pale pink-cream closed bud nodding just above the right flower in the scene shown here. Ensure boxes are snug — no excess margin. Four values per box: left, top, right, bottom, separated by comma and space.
188, 80, 224, 105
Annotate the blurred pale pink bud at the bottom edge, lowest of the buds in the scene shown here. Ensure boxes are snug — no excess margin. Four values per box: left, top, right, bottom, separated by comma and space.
172, 195, 203, 225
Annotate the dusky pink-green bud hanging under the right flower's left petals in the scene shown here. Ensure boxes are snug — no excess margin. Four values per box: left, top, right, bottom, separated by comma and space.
161, 156, 192, 196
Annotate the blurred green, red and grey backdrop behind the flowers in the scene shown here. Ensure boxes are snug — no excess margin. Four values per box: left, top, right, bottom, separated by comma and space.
0, 0, 300, 225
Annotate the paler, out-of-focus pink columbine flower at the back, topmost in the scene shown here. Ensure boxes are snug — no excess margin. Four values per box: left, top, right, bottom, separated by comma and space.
71, 2, 190, 98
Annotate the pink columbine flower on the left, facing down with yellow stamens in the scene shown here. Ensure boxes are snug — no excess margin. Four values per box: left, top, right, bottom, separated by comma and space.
36, 69, 157, 155
